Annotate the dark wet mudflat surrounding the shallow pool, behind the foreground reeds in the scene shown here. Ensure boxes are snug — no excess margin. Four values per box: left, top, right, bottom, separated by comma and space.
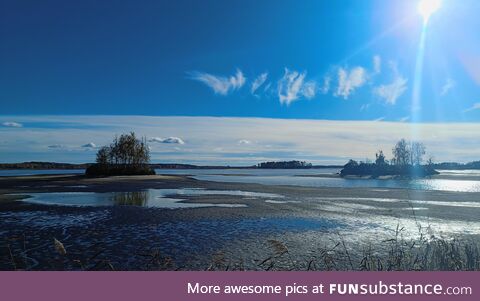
0, 175, 480, 270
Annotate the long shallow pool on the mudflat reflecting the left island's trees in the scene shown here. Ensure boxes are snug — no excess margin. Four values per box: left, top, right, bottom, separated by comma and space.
13, 188, 283, 209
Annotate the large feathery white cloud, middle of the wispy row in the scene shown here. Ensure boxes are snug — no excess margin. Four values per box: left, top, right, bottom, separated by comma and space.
278, 68, 317, 106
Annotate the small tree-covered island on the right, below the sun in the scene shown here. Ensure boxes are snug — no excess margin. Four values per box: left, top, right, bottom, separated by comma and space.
340, 139, 439, 178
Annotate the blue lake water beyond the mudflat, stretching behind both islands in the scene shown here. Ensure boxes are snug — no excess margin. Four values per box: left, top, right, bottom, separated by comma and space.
0, 168, 480, 192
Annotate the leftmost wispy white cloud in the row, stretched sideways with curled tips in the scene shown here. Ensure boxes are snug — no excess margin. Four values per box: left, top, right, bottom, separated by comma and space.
189, 69, 246, 95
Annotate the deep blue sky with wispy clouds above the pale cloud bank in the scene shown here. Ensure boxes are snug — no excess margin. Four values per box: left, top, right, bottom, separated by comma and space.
0, 0, 480, 162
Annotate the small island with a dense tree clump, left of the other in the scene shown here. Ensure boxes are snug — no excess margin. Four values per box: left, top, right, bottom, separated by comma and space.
85, 132, 155, 176
